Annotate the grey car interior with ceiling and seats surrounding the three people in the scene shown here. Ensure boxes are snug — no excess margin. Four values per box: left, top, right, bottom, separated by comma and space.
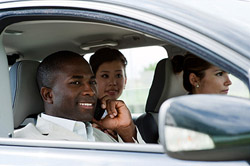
1, 13, 248, 143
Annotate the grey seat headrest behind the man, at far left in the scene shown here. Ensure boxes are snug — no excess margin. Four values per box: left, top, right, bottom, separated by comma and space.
10, 60, 44, 128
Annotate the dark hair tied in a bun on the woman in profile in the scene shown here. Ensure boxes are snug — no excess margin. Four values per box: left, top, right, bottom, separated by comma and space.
171, 53, 212, 93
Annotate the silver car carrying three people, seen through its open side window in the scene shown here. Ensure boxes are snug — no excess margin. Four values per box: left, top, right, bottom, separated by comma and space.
0, 0, 250, 166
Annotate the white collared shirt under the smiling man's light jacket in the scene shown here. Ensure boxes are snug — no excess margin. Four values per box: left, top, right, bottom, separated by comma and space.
41, 113, 95, 142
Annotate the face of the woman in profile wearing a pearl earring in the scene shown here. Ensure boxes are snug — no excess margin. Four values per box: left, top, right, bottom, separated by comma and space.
193, 66, 232, 94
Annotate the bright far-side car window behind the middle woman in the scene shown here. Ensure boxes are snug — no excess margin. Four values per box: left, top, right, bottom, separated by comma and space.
84, 46, 168, 114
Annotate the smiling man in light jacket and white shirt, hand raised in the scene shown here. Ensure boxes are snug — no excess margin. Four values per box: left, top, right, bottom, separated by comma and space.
14, 51, 144, 143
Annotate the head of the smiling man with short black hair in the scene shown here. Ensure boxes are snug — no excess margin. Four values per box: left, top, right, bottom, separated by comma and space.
37, 51, 97, 122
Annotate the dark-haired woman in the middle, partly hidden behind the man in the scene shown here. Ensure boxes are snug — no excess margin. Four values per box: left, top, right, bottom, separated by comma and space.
90, 48, 127, 139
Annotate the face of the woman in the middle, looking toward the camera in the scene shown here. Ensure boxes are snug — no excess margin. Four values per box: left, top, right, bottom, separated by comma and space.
96, 60, 127, 99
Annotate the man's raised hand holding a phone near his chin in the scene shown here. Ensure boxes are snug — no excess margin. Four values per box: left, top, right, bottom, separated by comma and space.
93, 96, 136, 142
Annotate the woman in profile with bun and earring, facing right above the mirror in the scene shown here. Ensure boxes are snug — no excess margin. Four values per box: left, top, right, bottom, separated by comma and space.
172, 53, 232, 94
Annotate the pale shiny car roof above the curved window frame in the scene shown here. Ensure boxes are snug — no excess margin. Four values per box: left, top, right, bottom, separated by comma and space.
101, 0, 250, 57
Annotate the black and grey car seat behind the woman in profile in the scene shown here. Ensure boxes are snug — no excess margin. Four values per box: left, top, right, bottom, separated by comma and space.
135, 58, 187, 143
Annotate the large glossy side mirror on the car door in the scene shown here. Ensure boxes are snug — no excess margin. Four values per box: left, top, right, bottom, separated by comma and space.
159, 95, 250, 161
